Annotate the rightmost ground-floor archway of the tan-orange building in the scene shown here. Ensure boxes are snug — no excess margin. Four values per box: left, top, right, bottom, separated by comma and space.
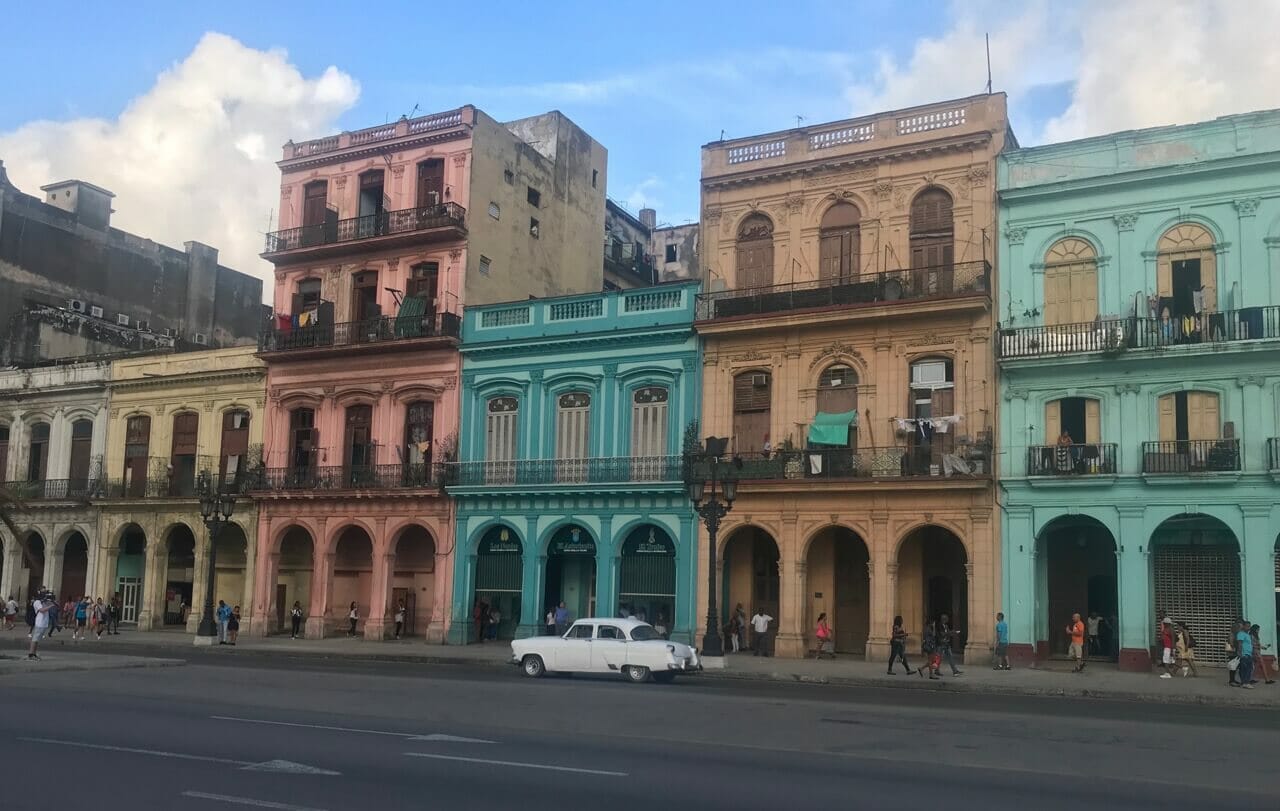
895, 524, 969, 654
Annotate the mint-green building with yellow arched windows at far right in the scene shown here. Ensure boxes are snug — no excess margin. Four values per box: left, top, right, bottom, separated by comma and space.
996, 111, 1280, 669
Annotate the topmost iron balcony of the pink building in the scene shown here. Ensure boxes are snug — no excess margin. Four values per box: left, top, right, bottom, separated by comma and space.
262, 202, 467, 262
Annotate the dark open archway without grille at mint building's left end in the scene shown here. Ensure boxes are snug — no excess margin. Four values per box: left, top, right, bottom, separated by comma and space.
1036, 516, 1120, 661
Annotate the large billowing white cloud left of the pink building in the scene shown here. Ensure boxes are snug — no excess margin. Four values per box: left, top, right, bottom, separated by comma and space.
0, 33, 360, 289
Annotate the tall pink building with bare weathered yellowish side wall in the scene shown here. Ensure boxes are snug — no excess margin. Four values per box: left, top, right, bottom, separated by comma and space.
253, 106, 607, 641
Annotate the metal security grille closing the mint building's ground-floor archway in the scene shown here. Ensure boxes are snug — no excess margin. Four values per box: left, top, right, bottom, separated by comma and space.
1152, 545, 1242, 665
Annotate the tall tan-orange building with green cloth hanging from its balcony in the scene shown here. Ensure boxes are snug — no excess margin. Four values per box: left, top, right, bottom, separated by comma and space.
696, 93, 1012, 659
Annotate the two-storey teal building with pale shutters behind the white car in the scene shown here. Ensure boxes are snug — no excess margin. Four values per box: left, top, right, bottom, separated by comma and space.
448, 283, 701, 643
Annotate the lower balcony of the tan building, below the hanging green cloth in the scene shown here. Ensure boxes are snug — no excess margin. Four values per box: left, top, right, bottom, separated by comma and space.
692, 445, 991, 484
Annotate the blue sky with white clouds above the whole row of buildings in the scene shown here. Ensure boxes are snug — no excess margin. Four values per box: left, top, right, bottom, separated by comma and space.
0, 0, 1280, 281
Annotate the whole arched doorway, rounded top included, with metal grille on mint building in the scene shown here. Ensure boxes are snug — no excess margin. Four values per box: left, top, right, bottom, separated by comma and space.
1148, 513, 1243, 664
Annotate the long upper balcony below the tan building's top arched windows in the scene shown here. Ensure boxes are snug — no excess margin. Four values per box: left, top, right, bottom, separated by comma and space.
696, 262, 991, 321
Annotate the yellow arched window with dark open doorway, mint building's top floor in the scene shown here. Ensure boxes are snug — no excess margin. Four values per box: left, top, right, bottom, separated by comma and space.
1156, 223, 1213, 322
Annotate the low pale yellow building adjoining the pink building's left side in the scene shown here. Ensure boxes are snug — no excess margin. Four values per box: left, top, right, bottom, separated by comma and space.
95, 347, 266, 629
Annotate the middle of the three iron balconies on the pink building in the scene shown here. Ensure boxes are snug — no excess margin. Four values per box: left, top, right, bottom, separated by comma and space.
257, 312, 462, 357
